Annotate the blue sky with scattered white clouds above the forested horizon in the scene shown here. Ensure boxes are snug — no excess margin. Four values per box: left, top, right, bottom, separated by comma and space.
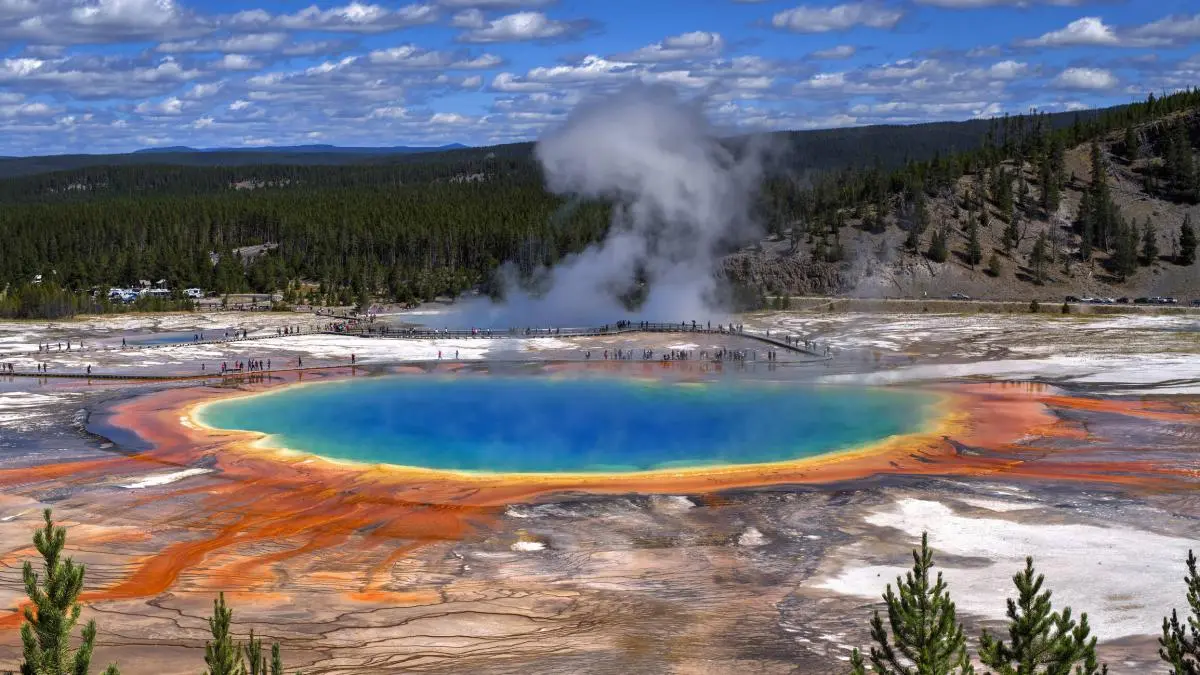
0, 0, 1200, 155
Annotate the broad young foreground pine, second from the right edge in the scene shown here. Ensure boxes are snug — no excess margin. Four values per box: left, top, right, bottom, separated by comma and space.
979, 557, 1108, 675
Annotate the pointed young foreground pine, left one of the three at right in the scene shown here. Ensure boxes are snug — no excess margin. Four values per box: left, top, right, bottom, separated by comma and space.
851, 533, 974, 675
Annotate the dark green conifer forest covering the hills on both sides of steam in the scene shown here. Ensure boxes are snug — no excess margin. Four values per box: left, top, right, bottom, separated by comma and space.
0, 91, 1200, 316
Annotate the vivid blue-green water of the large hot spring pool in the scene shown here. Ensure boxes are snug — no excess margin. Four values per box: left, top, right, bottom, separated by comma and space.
200, 375, 936, 473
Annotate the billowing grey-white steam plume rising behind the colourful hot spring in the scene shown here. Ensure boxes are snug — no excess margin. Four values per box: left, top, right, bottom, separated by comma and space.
446, 85, 762, 325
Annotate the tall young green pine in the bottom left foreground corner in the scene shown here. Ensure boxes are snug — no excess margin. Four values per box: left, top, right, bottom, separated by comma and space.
20, 509, 118, 675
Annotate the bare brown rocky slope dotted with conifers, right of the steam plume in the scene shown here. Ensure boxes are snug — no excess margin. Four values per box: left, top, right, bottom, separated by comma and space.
724, 112, 1200, 300
